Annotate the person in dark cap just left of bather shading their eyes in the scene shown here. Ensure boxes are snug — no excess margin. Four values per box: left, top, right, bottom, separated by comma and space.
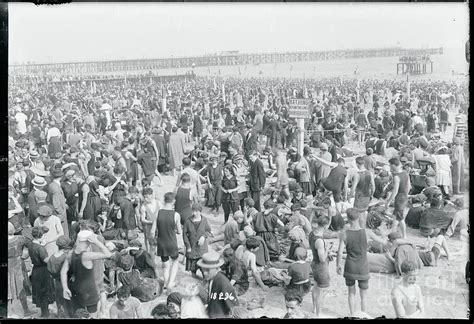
47, 235, 72, 318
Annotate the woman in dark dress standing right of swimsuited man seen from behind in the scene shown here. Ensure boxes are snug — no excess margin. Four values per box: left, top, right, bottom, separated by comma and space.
183, 204, 211, 278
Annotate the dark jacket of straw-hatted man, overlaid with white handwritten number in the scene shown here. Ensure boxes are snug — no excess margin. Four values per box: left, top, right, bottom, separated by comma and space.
207, 272, 239, 318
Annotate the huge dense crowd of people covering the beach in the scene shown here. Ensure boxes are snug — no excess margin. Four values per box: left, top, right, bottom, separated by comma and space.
8, 73, 469, 319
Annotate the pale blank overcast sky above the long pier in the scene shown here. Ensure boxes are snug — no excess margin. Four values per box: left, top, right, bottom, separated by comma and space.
8, 3, 469, 63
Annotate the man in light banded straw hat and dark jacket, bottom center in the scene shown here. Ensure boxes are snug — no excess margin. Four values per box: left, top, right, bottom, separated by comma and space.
197, 251, 239, 318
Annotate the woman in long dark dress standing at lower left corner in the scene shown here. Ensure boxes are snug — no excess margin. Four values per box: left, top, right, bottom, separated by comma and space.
28, 227, 55, 317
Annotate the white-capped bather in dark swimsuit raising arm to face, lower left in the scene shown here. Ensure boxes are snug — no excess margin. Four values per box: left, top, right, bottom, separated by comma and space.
61, 230, 112, 318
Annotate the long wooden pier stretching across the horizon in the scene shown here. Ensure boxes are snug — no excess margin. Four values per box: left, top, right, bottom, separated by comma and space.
9, 47, 443, 76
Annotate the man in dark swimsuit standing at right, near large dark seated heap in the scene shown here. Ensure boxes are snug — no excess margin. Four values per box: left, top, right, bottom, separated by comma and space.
385, 158, 411, 238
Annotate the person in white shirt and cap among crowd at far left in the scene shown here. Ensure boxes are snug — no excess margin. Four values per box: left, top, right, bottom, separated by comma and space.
33, 204, 63, 256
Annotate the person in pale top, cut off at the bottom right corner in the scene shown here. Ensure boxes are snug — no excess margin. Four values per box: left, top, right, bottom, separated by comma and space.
391, 261, 425, 318
